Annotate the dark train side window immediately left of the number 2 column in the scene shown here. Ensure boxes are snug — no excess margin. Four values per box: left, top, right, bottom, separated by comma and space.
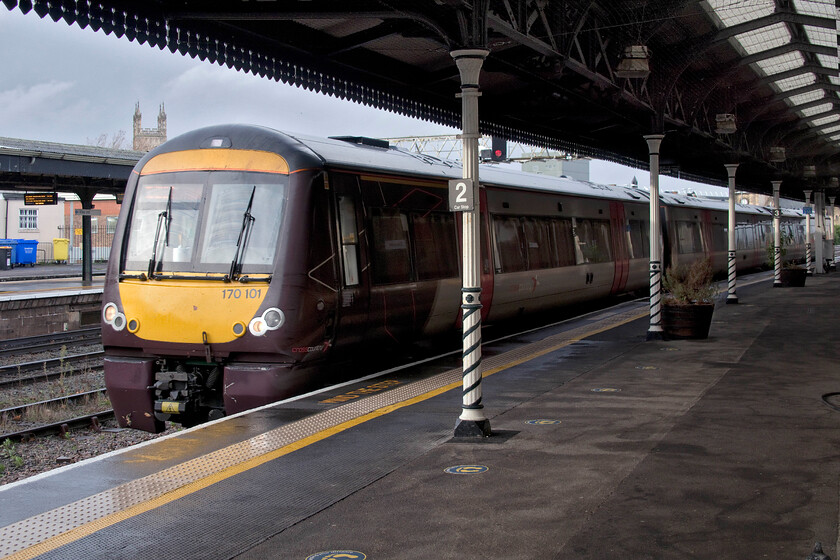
411, 213, 459, 280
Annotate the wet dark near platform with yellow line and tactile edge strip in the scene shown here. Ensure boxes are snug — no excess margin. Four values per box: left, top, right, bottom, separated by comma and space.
0, 275, 840, 560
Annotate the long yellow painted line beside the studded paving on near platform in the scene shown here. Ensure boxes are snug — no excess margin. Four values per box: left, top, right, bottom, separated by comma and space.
3, 309, 649, 560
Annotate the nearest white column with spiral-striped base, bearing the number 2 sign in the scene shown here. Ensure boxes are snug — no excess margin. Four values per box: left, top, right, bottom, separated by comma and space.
450, 49, 490, 437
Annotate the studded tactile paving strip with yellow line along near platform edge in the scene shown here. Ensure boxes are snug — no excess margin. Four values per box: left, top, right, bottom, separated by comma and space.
0, 306, 648, 560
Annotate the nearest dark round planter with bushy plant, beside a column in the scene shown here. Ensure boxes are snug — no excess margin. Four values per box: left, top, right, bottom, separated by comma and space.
662, 259, 716, 338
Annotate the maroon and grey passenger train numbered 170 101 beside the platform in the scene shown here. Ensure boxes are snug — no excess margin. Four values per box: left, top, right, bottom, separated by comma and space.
102, 125, 805, 432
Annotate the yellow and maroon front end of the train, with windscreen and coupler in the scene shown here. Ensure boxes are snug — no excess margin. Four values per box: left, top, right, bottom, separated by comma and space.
102, 126, 336, 432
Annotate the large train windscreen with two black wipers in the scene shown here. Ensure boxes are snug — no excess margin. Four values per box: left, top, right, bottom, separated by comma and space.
124, 171, 288, 274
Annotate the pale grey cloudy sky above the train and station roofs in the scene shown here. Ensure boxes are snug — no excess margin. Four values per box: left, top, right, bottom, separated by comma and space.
0, 4, 725, 194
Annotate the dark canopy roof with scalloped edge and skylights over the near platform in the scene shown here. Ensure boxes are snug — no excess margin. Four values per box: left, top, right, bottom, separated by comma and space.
0, 0, 840, 197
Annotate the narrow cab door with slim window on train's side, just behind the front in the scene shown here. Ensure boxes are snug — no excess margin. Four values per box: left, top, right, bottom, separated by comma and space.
331, 173, 370, 345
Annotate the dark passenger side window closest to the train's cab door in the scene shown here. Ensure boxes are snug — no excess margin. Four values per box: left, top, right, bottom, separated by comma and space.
370, 208, 411, 284
